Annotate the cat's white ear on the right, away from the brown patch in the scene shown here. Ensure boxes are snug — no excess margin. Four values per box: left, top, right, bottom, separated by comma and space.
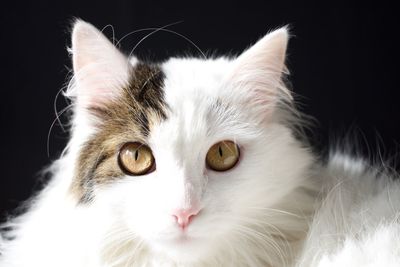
228, 27, 291, 120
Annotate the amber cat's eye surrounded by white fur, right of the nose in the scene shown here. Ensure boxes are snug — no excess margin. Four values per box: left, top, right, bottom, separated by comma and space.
206, 141, 240, 172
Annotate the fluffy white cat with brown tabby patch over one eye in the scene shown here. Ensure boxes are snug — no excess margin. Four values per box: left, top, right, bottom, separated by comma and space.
0, 20, 400, 267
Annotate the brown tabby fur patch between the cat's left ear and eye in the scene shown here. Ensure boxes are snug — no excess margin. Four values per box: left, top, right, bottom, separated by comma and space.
71, 63, 167, 203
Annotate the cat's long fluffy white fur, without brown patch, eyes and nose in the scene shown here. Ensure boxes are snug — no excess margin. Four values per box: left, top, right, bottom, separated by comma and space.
0, 22, 400, 267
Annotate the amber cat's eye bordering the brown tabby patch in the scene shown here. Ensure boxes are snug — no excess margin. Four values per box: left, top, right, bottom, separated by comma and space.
118, 142, 155, 175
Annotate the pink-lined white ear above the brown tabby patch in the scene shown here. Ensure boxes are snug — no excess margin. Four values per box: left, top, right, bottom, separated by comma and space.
71, 20, 131, 108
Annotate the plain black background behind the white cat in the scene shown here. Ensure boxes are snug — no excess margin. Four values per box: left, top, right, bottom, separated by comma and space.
0, 0, 400, 218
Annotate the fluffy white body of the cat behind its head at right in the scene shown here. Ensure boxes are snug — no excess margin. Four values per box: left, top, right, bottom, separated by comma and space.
297, 153, 400, 267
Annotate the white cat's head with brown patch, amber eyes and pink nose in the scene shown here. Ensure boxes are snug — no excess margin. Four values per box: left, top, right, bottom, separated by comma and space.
68, 21, 311, 261
